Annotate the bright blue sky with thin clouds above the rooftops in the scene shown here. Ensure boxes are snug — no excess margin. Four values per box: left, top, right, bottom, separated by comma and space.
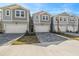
0, 3, 79, 15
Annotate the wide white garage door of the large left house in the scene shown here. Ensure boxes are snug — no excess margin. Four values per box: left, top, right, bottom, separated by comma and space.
5, 24, 27, 33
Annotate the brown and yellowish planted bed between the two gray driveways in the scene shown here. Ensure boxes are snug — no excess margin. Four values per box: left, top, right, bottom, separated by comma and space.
12, 34, 40, 45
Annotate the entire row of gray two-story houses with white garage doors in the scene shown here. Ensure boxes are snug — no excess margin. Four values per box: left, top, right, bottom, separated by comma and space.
0, 4, 79, 33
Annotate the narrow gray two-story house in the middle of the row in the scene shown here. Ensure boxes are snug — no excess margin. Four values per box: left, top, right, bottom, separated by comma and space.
32, 11, 51, 32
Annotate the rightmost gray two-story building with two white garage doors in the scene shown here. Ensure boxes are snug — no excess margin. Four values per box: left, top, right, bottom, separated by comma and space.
52, 12, 79, 32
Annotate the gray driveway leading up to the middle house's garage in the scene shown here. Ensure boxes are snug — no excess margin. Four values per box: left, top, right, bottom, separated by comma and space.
36, 33, 67, 46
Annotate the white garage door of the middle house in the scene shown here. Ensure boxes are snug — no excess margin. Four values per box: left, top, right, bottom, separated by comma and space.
34, 25, 50, 32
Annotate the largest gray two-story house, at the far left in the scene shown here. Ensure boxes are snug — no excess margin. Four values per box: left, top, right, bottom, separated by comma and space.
0, 4, 30, 33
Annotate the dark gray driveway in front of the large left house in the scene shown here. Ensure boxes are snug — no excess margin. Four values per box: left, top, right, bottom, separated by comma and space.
0, 34, 23, 46
